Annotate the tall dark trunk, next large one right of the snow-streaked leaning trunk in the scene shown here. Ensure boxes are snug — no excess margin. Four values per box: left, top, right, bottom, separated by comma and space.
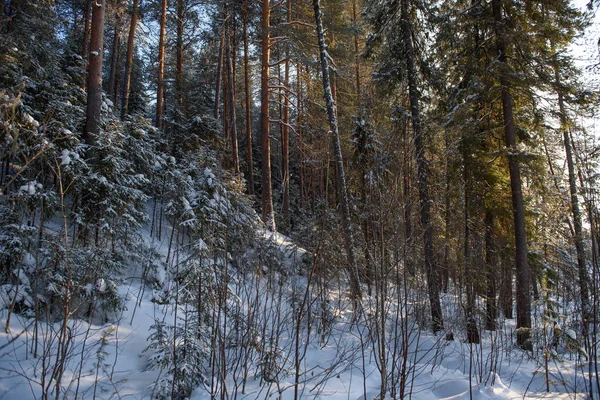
401, 0, 444, 332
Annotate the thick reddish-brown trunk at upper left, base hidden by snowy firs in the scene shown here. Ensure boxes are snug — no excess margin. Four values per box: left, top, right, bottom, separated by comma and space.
83, 0, 106, 145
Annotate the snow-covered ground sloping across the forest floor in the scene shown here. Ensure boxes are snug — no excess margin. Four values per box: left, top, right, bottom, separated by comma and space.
0, 223, 589, 400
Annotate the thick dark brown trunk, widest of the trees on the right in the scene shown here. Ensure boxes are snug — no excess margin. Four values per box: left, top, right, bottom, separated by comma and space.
492, 0, 532, 349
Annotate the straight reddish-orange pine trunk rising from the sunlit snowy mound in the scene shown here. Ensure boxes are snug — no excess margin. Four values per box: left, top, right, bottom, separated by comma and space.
260, 0, 276, 231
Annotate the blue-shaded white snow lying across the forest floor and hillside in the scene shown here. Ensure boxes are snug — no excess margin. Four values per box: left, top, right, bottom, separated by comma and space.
0, 208, 585, 400
